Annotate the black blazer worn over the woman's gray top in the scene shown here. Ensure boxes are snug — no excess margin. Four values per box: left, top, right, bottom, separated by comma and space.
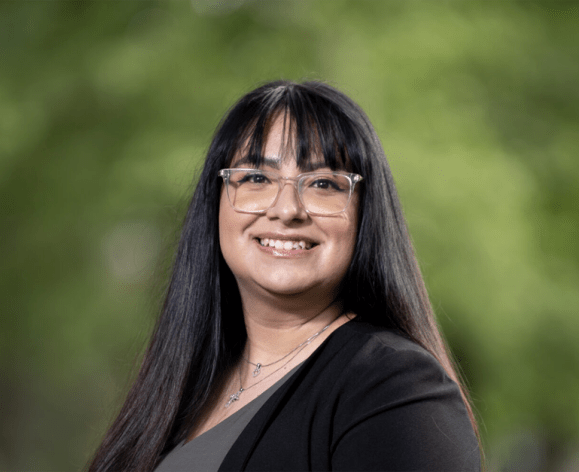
219, 320, 480, 472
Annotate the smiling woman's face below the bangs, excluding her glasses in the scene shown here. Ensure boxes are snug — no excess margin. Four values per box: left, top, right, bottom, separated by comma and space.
219, 119, 358, 299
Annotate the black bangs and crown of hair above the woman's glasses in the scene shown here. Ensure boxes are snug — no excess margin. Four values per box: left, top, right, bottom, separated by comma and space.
227, 82, 361, 172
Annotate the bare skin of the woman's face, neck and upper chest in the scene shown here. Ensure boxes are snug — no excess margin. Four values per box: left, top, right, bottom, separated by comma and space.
189, 118, 359, 439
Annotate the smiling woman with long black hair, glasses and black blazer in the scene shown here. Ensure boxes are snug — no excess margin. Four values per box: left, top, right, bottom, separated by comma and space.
90, 81, 480, 471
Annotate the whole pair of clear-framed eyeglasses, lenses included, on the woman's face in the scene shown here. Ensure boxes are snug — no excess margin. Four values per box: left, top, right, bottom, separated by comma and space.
219, 169, 362, 216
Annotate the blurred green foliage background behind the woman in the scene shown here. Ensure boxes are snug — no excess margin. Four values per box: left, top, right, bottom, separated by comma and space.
0, 0, 579, 471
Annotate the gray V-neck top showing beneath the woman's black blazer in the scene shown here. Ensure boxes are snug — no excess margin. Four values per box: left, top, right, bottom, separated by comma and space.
155, 364, 301, 472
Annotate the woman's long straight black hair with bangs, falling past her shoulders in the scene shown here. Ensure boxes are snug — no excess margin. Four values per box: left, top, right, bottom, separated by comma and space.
89, 81, 477, 472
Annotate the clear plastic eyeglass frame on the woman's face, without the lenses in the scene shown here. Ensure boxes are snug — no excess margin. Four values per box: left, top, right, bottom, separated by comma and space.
218, 167, 364, 216
